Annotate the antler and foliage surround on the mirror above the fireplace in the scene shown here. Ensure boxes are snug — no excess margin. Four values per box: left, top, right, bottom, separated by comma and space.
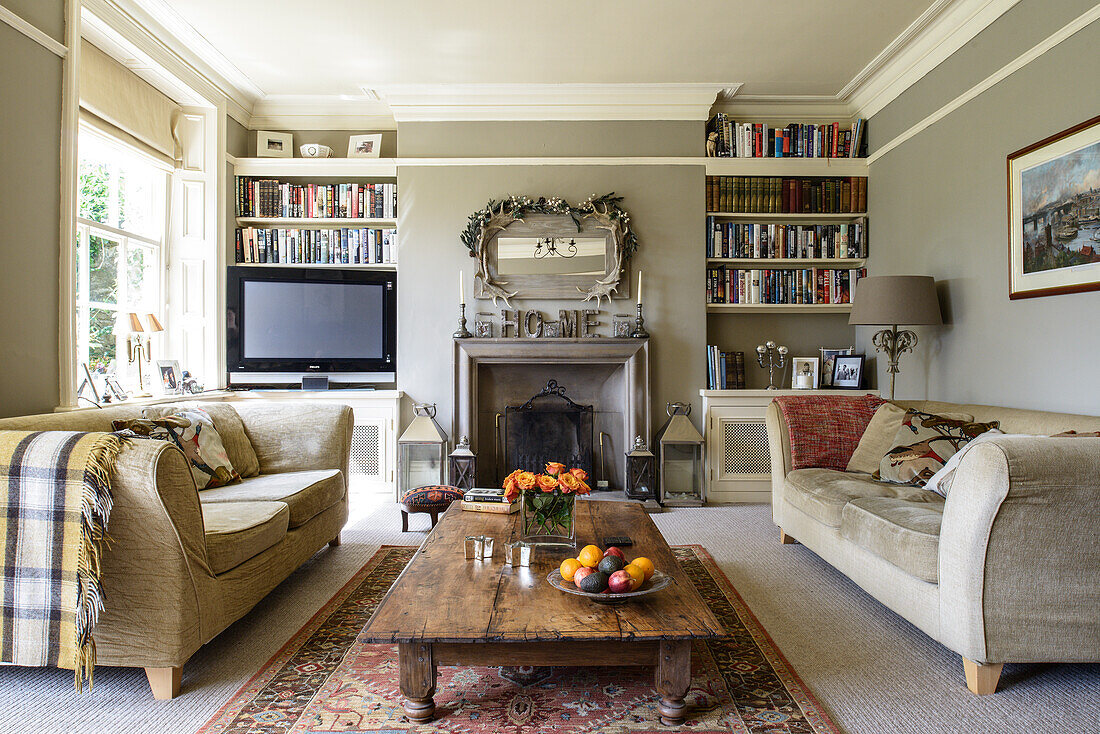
462, 191, 638, 308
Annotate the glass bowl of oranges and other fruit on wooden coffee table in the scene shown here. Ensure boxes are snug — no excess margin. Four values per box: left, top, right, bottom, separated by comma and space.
547, 546, 672, 604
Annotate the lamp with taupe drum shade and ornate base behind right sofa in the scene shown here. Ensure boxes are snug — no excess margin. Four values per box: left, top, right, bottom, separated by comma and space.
848, 275, 943, 399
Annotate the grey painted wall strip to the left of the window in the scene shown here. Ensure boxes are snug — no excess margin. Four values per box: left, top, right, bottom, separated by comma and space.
0, 15, 64, 416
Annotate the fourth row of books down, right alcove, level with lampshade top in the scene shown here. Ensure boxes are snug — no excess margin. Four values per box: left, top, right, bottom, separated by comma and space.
706, 267, 867, 305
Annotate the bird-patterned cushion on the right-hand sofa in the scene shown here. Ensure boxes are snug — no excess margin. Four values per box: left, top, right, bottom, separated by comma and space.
872, 408, 1000, 486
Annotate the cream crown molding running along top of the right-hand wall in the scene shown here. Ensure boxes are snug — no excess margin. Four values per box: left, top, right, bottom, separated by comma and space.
837, 0, 1020, 118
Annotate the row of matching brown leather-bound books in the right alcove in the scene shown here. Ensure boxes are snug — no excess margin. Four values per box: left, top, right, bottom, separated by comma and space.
706, 176, 867, 213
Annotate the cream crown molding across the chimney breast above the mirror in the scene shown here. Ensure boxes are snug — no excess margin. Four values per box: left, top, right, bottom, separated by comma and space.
374, 83, 740, 122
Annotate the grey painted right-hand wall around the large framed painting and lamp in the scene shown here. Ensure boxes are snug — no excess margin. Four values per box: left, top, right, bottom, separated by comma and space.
858, 0, 1100, 415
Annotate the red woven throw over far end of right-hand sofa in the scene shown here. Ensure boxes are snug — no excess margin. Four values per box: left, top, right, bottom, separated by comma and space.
776, 395, 886, 471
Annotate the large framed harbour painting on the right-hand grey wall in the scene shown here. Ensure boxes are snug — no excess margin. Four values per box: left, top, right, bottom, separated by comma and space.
1008, 117, 1100, 298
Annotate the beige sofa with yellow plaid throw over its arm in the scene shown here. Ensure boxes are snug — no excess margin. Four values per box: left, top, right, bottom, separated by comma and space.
0, 402, 352, 699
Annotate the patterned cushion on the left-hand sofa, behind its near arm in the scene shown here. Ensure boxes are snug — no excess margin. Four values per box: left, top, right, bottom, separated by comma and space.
112, 407, 241, 490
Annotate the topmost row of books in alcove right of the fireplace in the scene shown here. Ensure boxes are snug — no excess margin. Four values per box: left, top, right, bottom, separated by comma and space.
706, 112, 867, 158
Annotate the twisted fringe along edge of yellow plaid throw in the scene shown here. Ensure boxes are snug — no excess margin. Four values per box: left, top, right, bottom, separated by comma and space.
74, 434, 125, 693
